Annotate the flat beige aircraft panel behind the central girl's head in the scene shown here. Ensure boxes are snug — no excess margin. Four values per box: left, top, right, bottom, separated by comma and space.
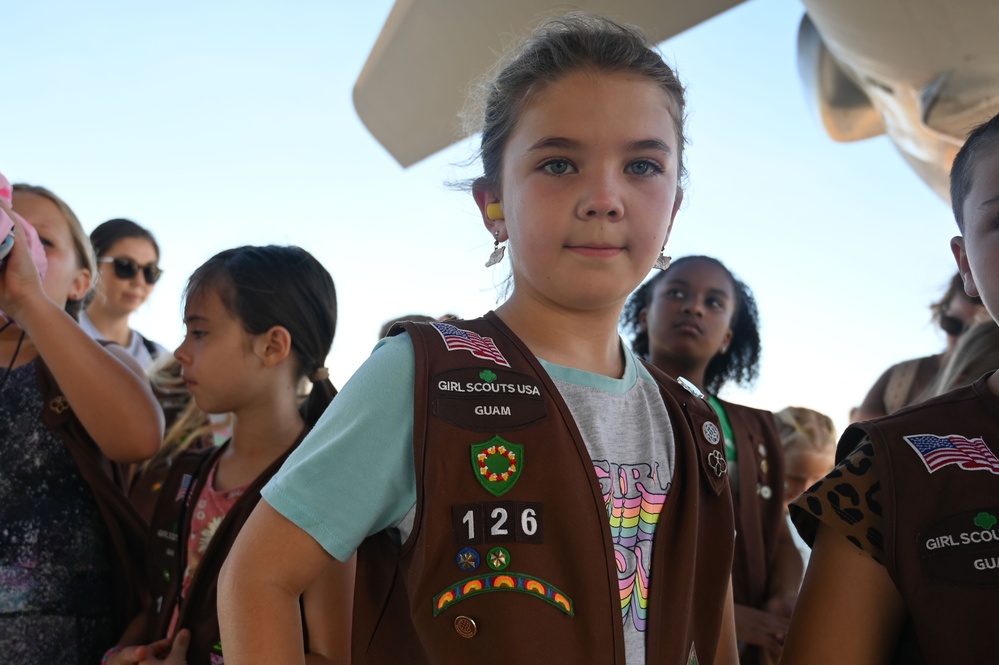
354, 0, 743, 166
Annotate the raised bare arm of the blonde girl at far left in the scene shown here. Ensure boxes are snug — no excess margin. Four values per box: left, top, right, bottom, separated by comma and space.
0, 214, 163, 462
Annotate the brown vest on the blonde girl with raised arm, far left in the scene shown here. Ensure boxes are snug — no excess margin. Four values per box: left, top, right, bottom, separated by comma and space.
37, 359, 148, 634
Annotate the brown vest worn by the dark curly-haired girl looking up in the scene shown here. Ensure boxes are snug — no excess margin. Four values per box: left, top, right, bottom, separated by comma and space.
719, 400, 793, 665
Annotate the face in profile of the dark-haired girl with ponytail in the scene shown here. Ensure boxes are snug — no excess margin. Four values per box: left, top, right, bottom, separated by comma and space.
173, 288, 261, 413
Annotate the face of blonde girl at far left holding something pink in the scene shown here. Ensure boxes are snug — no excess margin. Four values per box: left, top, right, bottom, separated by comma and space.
13, 191, 91, 307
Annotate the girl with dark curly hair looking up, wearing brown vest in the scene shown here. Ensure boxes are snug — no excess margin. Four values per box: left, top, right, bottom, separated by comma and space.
624, 256, 803, 665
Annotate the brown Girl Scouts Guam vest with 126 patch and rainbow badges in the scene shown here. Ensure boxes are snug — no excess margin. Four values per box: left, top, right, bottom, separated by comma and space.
352, 313, 734, 665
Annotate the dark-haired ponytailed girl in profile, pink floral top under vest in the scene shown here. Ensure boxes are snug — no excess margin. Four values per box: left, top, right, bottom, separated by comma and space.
105, 246, 350, 665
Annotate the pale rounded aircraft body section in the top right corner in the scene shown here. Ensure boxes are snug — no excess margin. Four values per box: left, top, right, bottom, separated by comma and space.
803, 0, 999, 200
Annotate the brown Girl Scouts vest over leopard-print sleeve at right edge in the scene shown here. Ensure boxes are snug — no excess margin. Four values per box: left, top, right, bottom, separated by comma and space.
837, 377, 999, 664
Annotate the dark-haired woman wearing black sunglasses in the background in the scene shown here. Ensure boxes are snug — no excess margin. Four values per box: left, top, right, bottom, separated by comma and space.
80, 219, 166, 368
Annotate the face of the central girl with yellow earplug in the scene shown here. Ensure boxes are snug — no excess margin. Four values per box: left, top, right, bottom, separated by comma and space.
476, 71, 682, 311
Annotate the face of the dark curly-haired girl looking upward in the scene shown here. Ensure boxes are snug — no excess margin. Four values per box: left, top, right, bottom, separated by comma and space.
643, 259, 736, 367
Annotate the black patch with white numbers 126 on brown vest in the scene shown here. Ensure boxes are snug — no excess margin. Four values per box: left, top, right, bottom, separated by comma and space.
451, 501, 544, 546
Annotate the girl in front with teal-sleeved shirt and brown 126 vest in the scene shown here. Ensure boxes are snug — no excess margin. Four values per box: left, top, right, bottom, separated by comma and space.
219, 15, 736, 665
